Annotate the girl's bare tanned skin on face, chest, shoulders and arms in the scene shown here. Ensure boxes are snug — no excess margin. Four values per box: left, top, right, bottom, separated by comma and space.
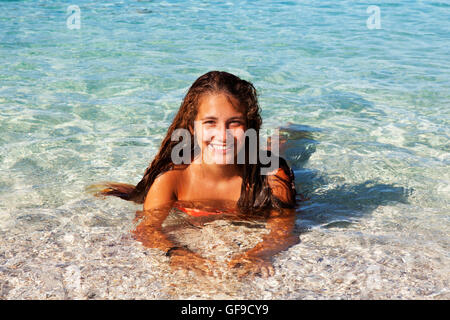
134, 94, 299, 277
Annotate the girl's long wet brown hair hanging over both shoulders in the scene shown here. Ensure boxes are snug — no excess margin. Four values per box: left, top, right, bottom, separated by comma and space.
90, 71, 296, 213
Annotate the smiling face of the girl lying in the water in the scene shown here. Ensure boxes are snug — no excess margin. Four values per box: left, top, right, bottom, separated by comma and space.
194, 94, 246, 164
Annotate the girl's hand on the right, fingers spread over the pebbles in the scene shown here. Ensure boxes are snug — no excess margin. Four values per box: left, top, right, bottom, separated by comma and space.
228, 253, 275, 278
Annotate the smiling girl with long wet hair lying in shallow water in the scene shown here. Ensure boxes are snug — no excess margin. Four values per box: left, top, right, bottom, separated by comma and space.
92, 71, 299, 276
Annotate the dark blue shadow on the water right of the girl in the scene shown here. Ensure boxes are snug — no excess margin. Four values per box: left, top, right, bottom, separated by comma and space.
280, 123, 411, 232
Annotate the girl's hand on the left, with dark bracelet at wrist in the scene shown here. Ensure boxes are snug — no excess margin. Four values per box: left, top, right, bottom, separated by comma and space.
170, 248, 215, 276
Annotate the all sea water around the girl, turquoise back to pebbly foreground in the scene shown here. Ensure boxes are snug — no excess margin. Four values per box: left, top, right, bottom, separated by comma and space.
0, 0, 450, 299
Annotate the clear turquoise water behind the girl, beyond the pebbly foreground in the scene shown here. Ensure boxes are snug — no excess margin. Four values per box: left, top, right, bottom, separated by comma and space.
0, 0, 450, 298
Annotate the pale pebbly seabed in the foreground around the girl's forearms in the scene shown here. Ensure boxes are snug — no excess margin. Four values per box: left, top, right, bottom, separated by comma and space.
0, 208, 450, 299
